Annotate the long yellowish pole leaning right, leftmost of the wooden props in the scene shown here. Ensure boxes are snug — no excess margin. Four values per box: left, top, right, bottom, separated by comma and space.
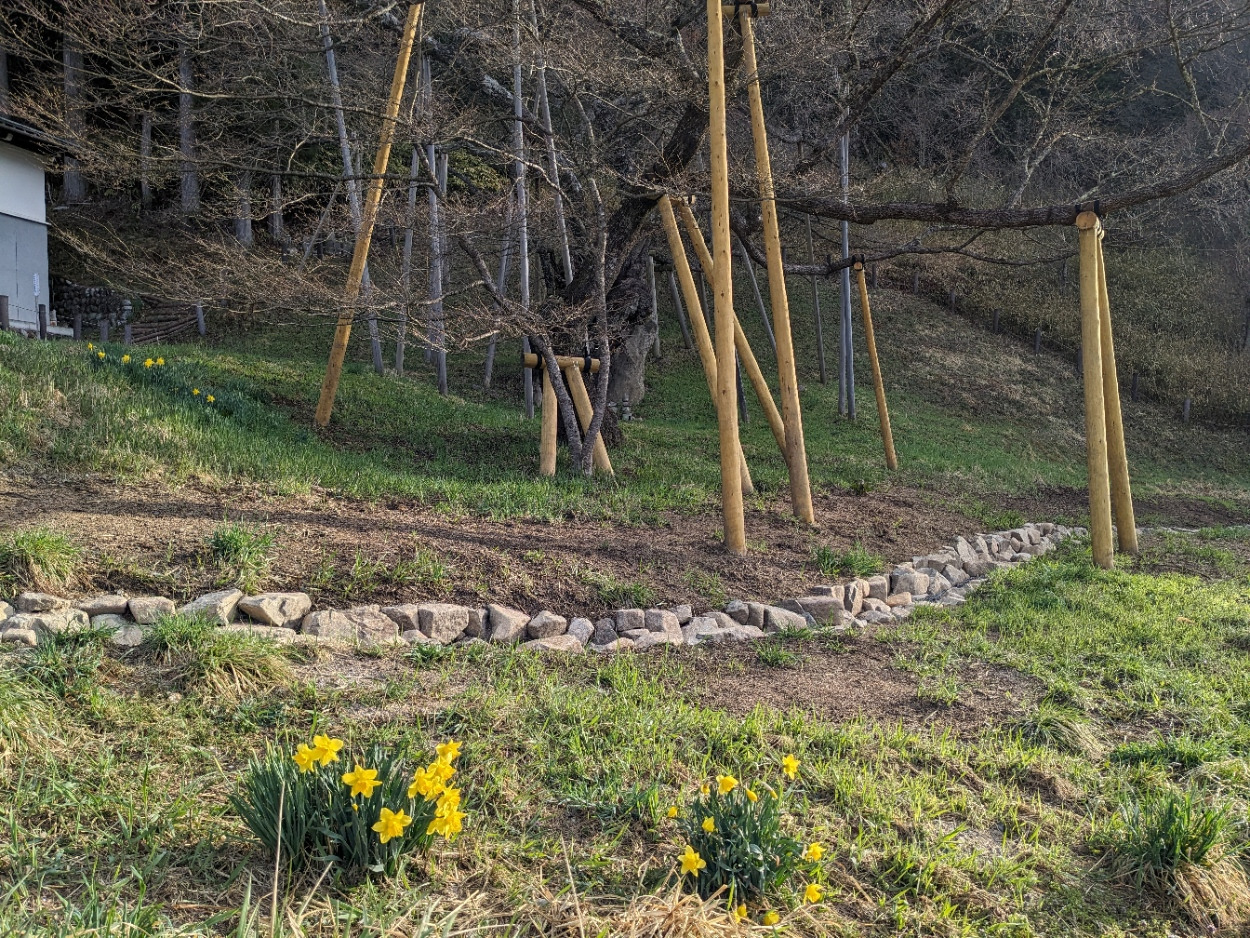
316, 0, 425, 426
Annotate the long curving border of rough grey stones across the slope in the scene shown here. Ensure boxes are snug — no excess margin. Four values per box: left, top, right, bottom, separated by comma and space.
0, 523, 1086, 654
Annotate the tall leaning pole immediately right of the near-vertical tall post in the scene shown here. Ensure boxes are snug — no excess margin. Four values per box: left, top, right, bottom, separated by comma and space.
735, 6, 816, 524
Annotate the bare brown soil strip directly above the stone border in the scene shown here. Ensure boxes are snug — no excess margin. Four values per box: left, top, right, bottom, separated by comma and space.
0, 472, 979, 615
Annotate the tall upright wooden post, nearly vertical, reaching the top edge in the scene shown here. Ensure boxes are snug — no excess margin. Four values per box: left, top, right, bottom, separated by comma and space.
708, 0, 746, 554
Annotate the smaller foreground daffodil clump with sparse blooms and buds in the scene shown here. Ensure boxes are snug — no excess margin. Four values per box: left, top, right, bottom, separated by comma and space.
666, 754, 825, 925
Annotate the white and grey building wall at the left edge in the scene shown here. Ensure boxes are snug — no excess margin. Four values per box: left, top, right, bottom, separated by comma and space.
0, 144, 51, 329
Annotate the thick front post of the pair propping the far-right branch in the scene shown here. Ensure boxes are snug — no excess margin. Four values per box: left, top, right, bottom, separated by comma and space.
1076, 211, 1115, 570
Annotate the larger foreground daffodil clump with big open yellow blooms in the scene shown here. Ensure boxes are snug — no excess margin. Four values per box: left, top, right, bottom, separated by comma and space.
231, 734, 466, 874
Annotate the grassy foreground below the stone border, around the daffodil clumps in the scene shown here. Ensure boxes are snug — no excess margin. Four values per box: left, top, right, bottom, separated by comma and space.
0, 529, 1250, 938
